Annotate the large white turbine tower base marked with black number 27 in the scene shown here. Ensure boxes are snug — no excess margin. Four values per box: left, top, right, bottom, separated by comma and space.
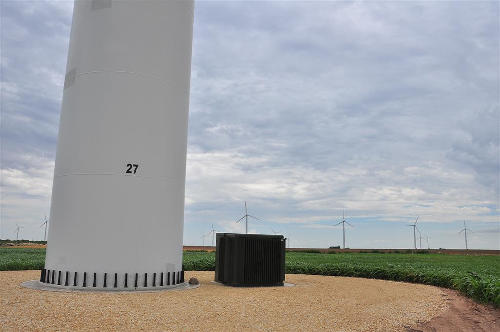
42, 0, 194, 289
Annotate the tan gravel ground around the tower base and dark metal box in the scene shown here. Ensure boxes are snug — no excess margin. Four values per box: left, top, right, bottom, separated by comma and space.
0, 271, 499, 331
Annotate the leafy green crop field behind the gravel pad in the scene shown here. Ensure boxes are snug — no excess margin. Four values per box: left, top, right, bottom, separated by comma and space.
0, 248, 500, 307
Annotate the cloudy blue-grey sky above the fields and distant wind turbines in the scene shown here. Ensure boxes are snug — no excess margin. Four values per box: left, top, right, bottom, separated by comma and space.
0, 0, 500, 249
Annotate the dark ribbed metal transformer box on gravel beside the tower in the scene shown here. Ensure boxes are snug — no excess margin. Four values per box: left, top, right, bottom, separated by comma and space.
215, 233, 285, 286
